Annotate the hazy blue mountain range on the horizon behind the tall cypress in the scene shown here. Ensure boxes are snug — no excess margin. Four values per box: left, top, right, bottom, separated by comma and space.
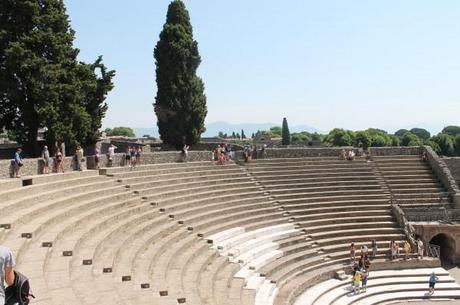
133, 121, 321, 138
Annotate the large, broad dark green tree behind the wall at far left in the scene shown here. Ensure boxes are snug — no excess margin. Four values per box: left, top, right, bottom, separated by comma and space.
0, 0, 114, 155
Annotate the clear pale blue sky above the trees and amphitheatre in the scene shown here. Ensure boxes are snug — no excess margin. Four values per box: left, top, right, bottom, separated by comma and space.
65, 0, 460, 132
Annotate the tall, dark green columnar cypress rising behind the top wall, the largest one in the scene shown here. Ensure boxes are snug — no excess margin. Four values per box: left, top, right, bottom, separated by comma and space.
154, 0, 207, 149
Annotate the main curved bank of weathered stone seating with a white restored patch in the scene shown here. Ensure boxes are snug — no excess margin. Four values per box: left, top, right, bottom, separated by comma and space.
0, 157, 458, 305
